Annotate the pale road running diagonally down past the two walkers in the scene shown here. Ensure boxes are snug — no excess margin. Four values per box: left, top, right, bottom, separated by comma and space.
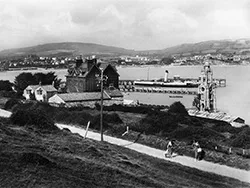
0, 109, 250, 183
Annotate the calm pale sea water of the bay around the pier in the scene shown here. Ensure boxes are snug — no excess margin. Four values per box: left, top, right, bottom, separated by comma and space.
0, 65, 250, 124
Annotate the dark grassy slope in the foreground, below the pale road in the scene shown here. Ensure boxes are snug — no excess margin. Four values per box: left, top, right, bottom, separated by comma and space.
0, 119, 250, 187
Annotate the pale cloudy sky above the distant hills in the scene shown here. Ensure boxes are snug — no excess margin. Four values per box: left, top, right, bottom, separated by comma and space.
0, 0, 250, 50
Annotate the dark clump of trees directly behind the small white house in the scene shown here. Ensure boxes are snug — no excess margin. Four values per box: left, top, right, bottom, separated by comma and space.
14, 72, 61, 96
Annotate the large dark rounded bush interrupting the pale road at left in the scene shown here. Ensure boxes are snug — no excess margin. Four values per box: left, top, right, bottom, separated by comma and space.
10, 109, 58, 131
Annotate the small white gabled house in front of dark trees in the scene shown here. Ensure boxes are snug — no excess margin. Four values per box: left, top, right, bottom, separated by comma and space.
23, 84, 57, 101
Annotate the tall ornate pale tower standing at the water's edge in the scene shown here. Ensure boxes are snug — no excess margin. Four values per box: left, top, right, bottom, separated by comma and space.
198, 61, 216, 112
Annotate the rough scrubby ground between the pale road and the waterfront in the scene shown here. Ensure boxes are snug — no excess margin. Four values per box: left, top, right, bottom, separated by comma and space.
5, 103, 250, 170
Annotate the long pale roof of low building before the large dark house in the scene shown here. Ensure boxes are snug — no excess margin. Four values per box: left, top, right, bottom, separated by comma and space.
57, 92, 111, 102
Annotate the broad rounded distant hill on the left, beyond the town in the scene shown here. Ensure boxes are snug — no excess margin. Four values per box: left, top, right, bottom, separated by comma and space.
0, 42, 134, 56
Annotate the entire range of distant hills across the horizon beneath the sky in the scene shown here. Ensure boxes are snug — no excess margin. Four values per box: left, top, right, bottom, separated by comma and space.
0, 39, 250, 57
